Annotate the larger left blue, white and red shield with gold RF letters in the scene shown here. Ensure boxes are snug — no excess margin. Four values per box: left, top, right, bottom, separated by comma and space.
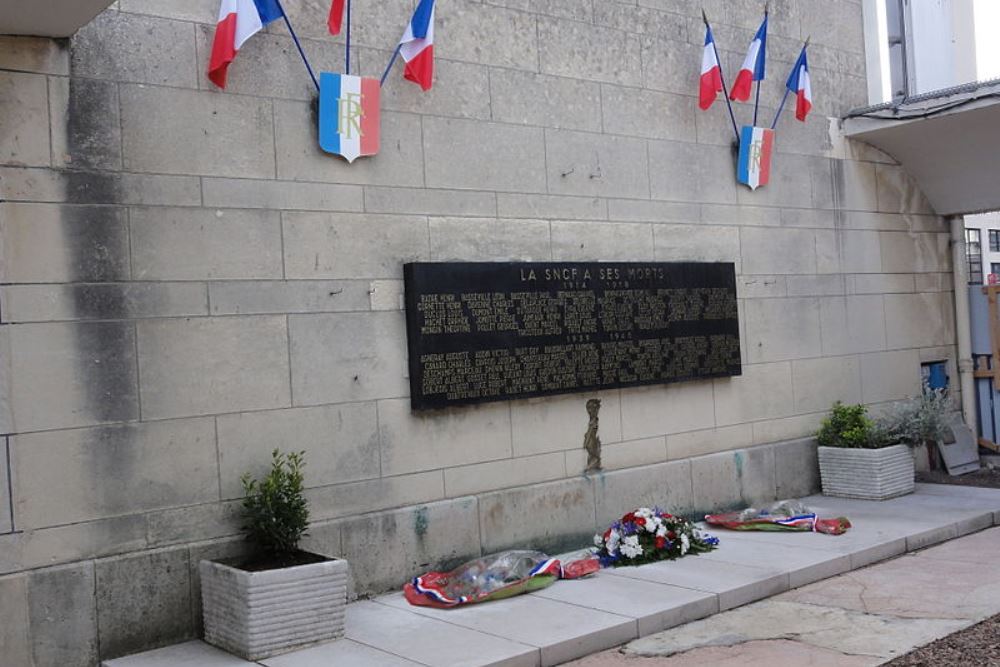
319, 72, 379, 162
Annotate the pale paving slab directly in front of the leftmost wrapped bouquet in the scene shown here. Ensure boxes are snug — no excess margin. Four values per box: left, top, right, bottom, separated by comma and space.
378, 584, 637, 667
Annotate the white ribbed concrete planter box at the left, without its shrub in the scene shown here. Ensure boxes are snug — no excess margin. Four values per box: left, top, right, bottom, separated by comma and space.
199, 560, 348, 660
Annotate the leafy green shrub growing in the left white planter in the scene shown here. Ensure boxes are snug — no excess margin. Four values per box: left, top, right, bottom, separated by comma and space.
240, 449, 309, 555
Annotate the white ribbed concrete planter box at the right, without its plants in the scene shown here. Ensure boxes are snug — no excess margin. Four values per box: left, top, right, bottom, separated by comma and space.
818, 445, 914, 500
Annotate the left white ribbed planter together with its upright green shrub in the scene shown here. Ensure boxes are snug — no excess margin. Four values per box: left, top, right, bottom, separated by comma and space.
199, 450, 347, 660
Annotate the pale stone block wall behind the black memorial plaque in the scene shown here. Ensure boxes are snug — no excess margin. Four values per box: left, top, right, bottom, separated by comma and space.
0, 0, 955, 667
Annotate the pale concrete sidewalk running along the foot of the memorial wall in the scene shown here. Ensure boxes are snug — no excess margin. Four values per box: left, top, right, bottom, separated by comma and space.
104, 485, 1000, 667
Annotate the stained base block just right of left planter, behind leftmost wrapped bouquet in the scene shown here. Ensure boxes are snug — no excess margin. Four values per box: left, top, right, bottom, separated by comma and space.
341, 498, 480, 593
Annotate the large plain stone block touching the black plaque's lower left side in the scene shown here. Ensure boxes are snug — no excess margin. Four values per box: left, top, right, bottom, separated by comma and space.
288, 311, 409, 405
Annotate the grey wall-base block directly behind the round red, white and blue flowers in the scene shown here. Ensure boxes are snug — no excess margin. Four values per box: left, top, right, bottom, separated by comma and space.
591, 461, 694, 531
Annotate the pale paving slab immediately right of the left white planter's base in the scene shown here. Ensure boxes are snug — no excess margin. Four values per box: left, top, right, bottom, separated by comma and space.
346, 602, 539, 667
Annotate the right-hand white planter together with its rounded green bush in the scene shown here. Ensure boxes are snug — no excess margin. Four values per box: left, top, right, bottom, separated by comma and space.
816, 401, 914, 500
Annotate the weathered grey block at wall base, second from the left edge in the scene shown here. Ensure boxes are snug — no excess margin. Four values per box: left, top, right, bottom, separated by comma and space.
28, 563, 103, 667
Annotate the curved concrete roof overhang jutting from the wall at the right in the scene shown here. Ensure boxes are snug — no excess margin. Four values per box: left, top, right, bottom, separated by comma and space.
844, 80, 1000, 215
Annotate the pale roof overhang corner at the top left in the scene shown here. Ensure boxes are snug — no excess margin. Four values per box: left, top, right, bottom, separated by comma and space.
0, 0, 113, 37
